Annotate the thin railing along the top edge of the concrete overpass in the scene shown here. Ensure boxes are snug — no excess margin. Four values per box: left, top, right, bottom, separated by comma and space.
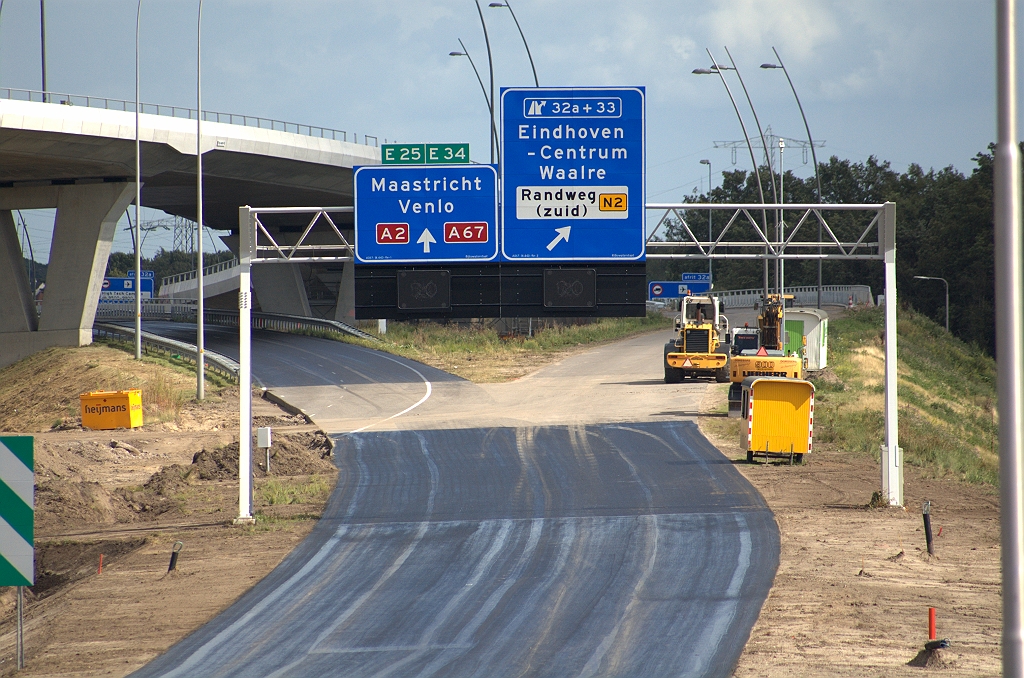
0, 87, 387, 146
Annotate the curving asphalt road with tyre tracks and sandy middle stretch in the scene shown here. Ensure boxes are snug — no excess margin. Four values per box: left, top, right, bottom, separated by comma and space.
125, 324, 779, 677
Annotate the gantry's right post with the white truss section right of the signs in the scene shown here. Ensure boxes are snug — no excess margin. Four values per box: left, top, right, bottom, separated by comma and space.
646, 203, 903, 506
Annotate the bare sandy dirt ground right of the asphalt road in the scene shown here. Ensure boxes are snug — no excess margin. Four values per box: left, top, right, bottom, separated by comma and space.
700, 385, 1001, 678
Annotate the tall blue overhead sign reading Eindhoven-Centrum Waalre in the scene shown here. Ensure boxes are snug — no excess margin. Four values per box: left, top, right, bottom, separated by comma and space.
502, 87, 646, 261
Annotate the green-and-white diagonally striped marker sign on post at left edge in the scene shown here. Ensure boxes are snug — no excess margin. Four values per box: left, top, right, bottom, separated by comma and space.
0, 435, 36, 669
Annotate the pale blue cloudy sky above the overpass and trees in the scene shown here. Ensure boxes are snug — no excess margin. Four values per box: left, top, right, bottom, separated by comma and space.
0, 0, 1011, 261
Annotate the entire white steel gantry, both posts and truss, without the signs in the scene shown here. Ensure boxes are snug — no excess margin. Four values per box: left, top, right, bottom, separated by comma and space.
236, 203, 903, 522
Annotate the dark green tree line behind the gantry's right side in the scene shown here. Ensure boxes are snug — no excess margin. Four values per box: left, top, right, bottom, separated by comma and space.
647, 145, 995, 354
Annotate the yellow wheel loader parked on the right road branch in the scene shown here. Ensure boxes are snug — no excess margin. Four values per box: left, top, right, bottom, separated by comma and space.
665, 296, 729, 384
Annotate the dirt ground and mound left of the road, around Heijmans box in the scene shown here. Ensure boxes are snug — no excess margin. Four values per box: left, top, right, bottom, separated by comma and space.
0, 346, 337, 676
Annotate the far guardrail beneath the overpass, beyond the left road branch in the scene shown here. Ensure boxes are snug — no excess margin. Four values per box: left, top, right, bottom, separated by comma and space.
94, 299, 380, 350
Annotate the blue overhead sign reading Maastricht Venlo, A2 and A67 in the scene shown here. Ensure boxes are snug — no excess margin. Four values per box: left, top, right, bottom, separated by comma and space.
353, 165, 498, 264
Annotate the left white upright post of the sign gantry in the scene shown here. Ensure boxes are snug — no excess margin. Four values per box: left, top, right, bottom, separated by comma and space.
234, 205, 256, 523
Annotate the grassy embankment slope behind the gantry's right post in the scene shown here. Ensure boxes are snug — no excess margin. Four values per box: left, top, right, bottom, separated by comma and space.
811, 308, 998, 484
